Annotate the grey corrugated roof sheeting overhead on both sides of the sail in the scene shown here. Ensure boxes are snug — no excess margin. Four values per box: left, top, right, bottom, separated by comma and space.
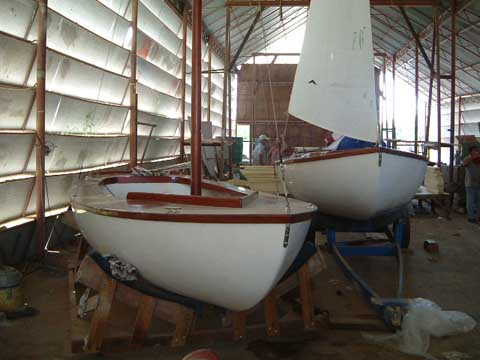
195, 0, 480, 96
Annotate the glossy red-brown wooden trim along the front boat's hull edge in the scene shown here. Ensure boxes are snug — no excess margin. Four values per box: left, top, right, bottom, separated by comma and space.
73, 201, 313, 224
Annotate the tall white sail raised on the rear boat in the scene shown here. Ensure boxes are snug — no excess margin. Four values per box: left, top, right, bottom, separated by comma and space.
289, 0, 377, 142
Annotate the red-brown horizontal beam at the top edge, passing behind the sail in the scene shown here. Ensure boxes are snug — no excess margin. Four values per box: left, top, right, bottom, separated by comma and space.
225, 0, 435, 7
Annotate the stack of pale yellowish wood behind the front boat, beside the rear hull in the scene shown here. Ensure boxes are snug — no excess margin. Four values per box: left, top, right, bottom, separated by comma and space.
230, 165, 283, 194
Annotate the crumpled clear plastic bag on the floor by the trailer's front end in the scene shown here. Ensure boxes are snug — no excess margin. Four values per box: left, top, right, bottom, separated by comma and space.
365, 298, 476, 357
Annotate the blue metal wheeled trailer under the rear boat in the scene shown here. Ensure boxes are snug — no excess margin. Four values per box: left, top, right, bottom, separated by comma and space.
314, 209, 410, 329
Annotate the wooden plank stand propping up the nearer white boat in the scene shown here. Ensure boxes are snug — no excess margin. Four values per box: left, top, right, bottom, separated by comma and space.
67, 245, 321, 353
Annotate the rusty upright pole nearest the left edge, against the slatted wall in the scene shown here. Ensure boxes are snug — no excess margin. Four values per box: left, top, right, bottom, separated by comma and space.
35, 0, 48, 257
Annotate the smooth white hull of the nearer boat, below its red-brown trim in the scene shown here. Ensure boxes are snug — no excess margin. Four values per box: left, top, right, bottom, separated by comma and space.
73, 212, 310, 311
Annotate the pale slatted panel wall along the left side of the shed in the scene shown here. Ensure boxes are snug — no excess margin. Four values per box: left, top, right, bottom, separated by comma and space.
0, 0, 223, 224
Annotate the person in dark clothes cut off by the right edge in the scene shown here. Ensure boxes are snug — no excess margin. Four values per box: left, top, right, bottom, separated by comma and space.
463, 145, 480, 223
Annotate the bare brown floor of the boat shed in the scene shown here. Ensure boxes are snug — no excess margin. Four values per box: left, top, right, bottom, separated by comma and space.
0, 215, 480, 360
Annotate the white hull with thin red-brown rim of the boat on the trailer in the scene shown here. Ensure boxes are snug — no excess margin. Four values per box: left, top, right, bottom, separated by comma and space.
283, 149, 427, 220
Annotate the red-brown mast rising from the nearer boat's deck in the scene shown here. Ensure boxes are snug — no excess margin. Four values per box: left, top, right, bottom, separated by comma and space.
190, 0, 202, 195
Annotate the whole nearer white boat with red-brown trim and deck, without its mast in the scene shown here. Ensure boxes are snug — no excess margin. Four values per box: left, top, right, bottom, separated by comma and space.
72, 177, 316, 311
